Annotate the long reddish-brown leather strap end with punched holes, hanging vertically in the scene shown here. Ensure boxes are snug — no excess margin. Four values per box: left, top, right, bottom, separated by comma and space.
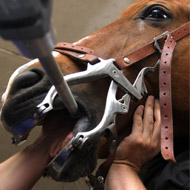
159, 36, 176, 162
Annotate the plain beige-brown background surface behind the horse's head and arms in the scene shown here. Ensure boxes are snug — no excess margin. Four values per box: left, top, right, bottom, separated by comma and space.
0, 0, 135, 190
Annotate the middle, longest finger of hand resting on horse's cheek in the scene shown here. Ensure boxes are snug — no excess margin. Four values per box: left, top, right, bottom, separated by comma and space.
143, 96, 154, 137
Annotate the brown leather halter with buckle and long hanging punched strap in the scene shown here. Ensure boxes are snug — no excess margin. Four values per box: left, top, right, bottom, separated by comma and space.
54, 22, 190, 162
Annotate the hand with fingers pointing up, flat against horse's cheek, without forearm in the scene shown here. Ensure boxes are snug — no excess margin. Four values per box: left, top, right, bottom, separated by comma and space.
113, 96, 160, 171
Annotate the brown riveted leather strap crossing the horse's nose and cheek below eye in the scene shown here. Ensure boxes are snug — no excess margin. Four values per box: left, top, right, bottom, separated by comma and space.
54, 22, 190, 70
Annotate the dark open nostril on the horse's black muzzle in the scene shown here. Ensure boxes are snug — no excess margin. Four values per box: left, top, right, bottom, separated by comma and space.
10, 69, 44, 94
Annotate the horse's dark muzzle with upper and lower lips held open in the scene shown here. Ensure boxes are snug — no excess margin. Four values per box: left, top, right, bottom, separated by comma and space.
1, 65, 103, 181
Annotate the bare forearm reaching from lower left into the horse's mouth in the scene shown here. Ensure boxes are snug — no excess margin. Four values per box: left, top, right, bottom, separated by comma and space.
0, 110, 72, 190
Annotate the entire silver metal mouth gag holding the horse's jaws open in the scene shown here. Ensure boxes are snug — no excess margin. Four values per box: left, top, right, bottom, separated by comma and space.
9, 55, 159, 187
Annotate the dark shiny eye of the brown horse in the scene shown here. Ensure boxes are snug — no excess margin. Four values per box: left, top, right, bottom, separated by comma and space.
139, 6, 172, 21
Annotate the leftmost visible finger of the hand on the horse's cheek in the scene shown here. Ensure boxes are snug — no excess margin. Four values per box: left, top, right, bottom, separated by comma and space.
132, 105, 144, 135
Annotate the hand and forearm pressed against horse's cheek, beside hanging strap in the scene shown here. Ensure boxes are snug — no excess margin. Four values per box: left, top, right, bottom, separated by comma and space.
106, 96, 160, 190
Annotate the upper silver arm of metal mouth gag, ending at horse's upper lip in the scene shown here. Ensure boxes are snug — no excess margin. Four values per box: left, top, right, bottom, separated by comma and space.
9, 58, 142, 144
